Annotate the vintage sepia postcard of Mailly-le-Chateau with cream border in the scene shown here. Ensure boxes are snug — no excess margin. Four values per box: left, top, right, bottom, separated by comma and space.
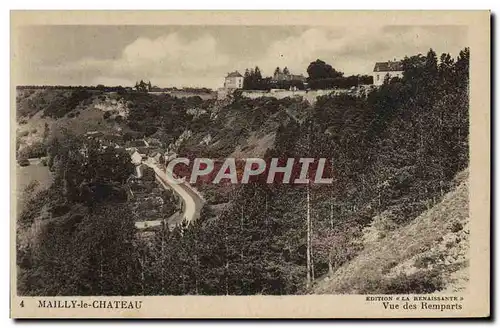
10, 11, 490, 318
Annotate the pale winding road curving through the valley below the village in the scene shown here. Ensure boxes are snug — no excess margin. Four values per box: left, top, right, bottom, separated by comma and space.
135, 158, 205, 229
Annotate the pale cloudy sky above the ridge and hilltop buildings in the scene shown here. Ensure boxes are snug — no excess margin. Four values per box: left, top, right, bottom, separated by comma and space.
16, 25, 468, 88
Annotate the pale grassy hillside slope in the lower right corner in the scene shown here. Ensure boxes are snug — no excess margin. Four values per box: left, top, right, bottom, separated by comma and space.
313, 170, 469, 294
